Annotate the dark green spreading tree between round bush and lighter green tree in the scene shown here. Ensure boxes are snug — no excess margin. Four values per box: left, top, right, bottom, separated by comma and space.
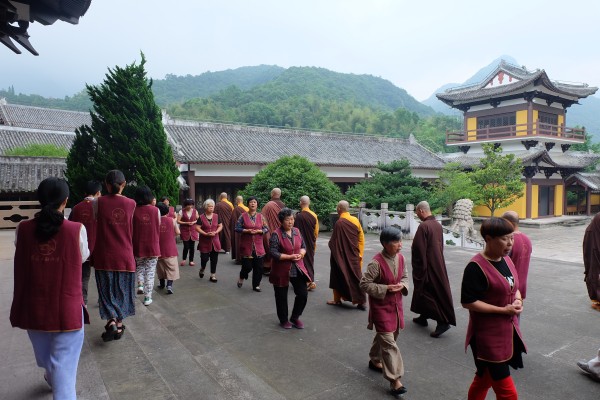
346, 160, 429, 211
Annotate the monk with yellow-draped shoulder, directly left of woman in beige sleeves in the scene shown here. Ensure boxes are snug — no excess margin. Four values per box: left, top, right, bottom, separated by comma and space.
327, 200, 367, 310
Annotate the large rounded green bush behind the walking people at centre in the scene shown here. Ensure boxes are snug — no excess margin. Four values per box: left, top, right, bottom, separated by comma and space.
240, 156, 342, 225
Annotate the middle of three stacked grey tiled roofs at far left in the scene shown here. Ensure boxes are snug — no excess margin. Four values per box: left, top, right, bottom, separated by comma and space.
0, 126, 75, 155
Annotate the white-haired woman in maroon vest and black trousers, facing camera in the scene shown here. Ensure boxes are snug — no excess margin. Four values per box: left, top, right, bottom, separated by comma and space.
196, 199, 223, 282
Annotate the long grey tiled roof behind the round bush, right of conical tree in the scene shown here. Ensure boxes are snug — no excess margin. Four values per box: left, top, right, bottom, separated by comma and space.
165, 123, 444, 169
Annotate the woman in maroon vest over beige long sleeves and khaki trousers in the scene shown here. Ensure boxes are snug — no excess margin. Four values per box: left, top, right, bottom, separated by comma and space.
360, 227, 408, 398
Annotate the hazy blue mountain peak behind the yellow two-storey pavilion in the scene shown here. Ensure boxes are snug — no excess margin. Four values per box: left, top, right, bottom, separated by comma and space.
422, 55, 600, 142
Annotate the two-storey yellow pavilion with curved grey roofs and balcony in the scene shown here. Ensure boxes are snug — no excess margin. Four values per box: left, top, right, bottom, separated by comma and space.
436, 61, 600, 218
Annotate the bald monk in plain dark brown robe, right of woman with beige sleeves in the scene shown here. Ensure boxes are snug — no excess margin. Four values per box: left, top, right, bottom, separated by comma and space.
410, 201, 456, 338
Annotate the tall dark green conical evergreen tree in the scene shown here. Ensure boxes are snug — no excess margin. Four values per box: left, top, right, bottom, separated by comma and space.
65, 54, 179, 203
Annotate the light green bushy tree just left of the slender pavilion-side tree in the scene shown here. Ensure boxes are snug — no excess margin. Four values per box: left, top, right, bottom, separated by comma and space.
431, 163, 480, 215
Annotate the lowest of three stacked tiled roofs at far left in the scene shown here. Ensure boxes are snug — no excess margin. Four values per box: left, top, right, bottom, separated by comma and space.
0, 156, 67, 193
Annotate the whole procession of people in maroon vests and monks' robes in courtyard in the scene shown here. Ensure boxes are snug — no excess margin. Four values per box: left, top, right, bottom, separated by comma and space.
10, 170, 600, 400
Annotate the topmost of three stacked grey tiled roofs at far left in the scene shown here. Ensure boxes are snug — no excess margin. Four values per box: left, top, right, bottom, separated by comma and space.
0, 104, 92, 132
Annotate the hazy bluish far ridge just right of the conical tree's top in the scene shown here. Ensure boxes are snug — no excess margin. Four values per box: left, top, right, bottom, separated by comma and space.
152, 65, 285, 107
